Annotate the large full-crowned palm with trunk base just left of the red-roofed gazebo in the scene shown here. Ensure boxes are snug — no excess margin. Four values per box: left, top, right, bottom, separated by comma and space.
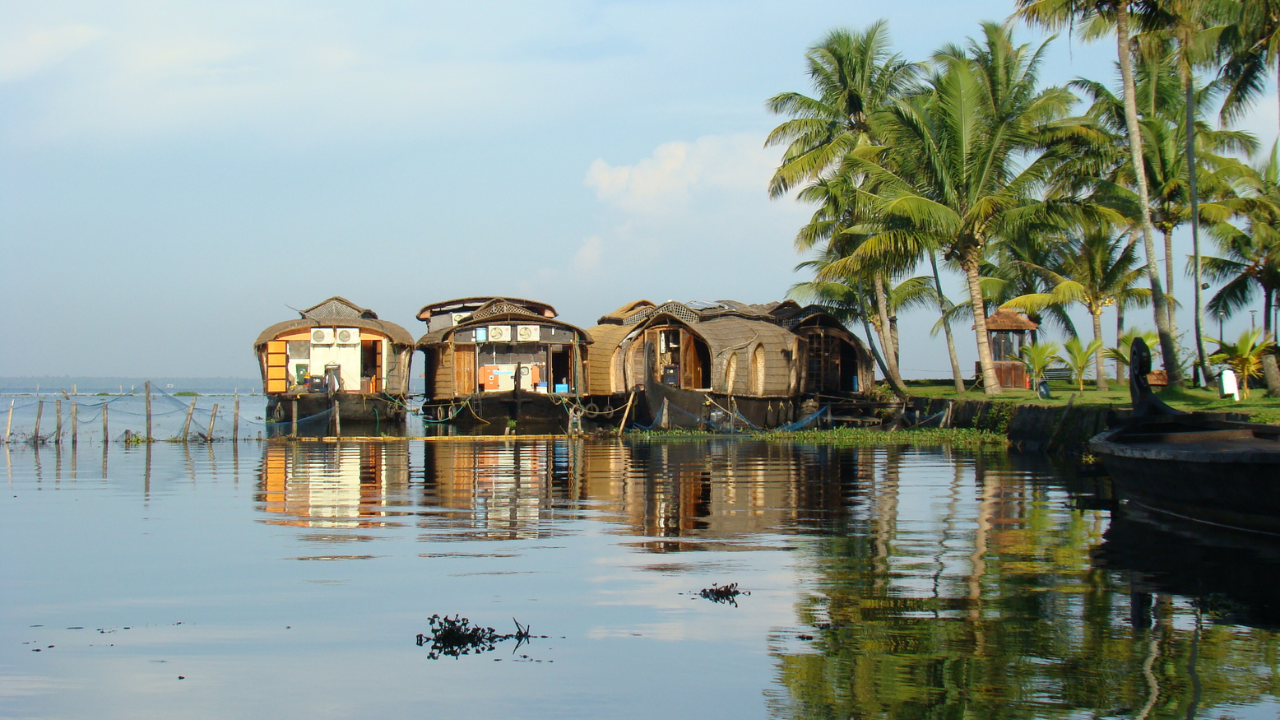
829, 23, 1074, 395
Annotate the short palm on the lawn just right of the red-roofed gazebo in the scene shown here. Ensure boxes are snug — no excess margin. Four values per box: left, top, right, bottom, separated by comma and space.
1002, 228, 1151, 391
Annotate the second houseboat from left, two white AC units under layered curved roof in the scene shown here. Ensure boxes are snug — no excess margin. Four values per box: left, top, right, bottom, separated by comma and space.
417, 297, 591, 432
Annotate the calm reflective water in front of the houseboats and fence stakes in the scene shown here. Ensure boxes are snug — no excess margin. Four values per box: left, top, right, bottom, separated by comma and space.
0, 439, 1280, 719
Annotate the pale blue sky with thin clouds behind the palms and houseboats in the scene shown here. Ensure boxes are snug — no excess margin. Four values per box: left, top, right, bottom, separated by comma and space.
0, 0, 1276, 378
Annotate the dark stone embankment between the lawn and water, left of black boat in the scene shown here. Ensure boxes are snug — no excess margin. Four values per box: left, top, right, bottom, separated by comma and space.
910, 397, 1130, 454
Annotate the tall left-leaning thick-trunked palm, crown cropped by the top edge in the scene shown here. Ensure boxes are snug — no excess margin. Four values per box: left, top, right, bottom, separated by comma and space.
1014, 0, 1181, 383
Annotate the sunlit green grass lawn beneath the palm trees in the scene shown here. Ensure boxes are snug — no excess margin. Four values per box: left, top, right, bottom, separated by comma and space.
906, 382, 1280, 423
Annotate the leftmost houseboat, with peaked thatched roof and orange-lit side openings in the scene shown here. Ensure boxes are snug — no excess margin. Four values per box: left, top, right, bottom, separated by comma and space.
253, 297, 413, 434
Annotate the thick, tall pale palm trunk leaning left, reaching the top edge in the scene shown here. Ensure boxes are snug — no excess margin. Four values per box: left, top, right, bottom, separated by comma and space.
1116, 8, 1183, 384
